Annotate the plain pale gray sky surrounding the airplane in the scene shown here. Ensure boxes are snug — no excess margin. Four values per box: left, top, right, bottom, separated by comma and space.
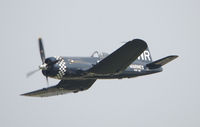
0, 0, 200, 127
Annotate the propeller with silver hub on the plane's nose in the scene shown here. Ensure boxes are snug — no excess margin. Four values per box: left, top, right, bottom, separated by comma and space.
26, 38, 49, 86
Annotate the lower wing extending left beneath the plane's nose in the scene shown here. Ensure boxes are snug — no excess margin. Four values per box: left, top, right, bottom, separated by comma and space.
22, 80, 96, 97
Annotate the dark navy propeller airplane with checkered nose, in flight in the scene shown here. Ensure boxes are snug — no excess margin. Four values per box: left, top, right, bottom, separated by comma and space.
21, 38, 178, 97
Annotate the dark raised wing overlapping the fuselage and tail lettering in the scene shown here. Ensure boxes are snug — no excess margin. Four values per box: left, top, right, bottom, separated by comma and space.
89, 39, 147, 75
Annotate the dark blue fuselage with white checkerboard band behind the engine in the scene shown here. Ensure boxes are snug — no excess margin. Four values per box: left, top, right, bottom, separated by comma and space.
43, 57, 162, 80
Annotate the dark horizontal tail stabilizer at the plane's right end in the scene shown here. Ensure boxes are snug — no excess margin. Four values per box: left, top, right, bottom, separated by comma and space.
147, 55, 178, 69
